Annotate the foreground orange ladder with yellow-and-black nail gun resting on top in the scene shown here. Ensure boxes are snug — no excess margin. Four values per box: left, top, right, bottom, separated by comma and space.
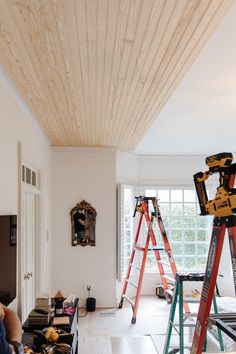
191, 153, 236, 354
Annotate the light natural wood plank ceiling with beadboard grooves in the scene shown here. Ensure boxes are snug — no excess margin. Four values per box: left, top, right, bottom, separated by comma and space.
0, 0, 232, 151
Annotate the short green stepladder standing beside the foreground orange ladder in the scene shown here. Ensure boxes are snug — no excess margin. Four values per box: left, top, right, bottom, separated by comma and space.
163, 272, 224, 354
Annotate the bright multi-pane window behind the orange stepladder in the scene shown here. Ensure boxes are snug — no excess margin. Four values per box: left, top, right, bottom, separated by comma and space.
121, 187, 212, 274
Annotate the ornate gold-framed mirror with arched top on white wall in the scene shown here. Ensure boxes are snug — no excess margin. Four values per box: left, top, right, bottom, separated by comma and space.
70, 200, 97, 246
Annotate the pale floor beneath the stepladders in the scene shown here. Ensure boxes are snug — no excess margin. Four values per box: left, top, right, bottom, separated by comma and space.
78, 296, 236, 354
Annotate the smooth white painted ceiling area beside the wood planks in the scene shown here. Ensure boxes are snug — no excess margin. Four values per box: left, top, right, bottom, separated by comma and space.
135, 1, 236, 155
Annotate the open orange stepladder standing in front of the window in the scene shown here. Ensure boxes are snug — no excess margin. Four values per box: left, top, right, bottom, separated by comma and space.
119, 196, 190, 324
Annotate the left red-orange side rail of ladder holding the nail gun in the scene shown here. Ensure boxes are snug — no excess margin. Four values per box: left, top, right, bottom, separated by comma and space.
191, 218, 226, 354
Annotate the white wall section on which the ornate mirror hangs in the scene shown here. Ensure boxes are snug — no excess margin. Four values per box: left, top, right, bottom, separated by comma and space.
52, 148, 116, 306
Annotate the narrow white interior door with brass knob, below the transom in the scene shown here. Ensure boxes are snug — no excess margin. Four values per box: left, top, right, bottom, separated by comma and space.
22, 192, 36, 321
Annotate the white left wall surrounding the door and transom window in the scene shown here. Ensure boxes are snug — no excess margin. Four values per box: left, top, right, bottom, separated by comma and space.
0, 67, 51, 312
